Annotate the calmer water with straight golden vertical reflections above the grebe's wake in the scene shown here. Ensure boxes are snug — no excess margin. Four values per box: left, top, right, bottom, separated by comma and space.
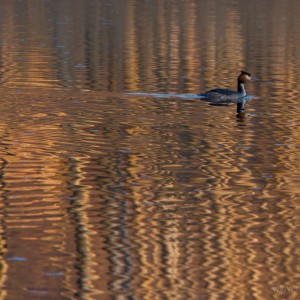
0, 0, 299, 93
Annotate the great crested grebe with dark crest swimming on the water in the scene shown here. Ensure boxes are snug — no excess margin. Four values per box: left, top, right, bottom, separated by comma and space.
198, 71, 251, 101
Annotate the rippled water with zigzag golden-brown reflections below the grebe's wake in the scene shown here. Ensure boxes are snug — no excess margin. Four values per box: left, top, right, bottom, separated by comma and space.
1, 90, 299, 299
